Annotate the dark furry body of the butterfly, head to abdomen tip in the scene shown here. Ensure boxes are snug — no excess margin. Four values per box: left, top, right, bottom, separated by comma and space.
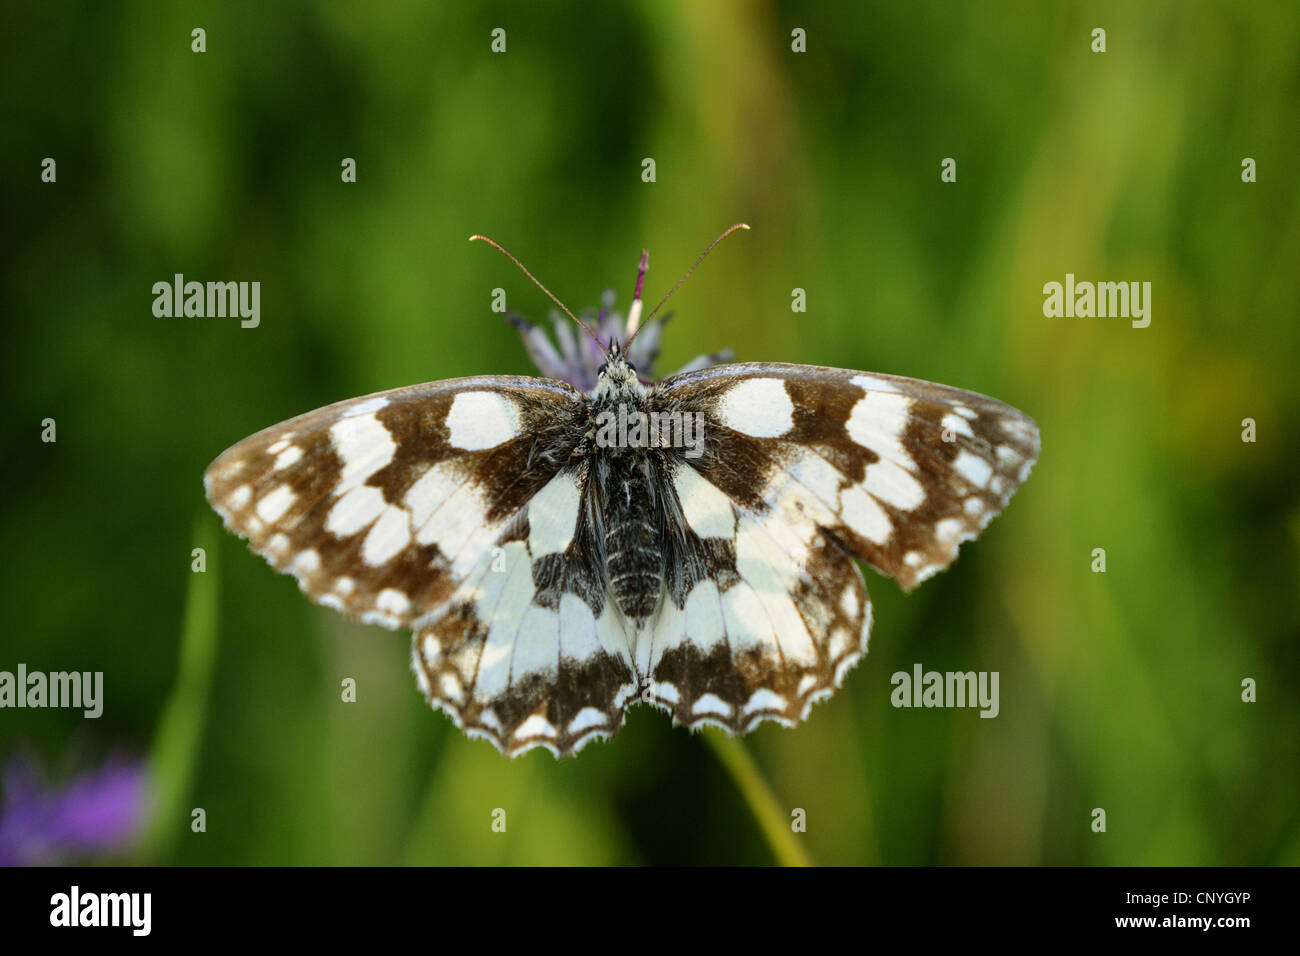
588, 343, 664, 627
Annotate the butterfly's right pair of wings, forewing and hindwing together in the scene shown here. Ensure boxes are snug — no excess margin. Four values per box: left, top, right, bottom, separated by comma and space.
637, 363, 1039, 732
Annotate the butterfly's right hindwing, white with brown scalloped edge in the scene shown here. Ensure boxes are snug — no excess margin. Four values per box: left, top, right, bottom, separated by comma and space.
637, 462, 871, 734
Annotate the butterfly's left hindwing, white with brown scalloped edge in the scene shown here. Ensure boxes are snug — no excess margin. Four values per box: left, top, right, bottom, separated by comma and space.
412, 464, 638, 756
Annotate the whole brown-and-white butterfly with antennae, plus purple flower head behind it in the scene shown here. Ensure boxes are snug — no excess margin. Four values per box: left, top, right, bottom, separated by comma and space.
204, 224, 1039, 756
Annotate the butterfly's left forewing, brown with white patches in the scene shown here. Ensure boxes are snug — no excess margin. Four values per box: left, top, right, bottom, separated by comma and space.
204, 376, 586, 627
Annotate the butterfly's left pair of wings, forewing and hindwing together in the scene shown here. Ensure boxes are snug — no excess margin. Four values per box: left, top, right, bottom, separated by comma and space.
204, 376, 636, 753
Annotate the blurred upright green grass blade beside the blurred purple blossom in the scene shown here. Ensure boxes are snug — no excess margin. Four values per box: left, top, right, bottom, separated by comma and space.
146, 514, 221, 861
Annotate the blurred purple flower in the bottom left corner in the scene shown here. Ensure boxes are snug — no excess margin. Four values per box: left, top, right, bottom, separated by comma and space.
0, 757, 147, 866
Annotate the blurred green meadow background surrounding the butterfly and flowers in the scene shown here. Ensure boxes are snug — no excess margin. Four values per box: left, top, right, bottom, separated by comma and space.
0, 0, 1300, 864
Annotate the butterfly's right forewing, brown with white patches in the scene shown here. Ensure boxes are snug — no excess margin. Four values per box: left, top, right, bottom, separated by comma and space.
659, 363, 1039, 589
